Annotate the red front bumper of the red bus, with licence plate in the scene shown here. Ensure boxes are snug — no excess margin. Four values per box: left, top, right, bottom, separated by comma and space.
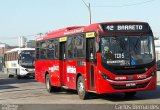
97, 76, 157, 94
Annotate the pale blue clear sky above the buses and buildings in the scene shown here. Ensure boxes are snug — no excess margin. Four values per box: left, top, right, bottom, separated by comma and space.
0, 0, 160, 45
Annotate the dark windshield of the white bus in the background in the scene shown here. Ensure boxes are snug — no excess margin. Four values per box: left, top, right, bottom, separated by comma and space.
19, 51, 34, 67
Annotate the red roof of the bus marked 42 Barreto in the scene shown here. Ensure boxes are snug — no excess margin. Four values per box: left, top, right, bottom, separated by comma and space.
36, 21, 148, 41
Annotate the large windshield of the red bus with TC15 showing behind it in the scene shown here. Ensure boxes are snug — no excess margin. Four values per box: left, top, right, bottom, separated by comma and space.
101, 36, 154, 66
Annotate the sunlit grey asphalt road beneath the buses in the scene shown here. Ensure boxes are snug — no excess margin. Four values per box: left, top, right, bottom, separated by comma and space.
0, 72, 160, 104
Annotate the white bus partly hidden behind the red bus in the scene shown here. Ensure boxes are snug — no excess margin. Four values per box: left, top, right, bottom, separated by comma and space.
4, 48, 35, 79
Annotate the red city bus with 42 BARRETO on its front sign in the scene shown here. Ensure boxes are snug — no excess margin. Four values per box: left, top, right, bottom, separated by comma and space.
35, 21, 157, 99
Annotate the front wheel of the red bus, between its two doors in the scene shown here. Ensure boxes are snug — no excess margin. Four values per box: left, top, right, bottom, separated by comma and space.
77, 76, 87, 100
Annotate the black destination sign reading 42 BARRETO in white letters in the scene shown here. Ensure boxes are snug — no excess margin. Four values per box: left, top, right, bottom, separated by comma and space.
101, 23, 149, 32
